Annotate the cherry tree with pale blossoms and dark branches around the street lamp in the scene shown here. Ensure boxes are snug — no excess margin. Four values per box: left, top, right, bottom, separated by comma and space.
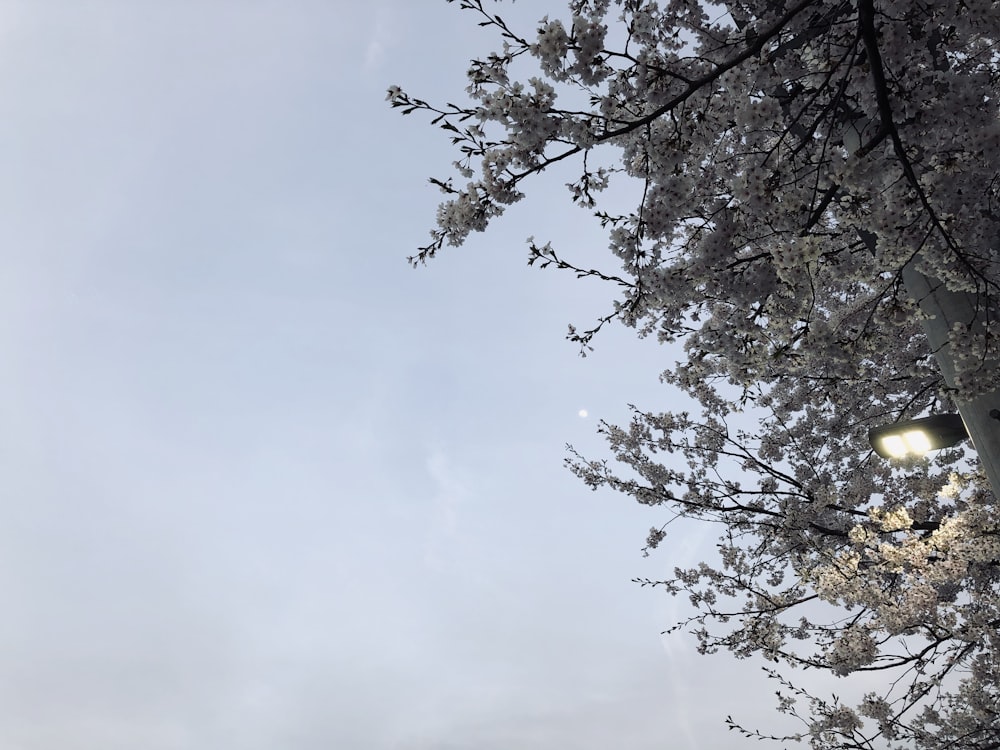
389, 0, 1000, 750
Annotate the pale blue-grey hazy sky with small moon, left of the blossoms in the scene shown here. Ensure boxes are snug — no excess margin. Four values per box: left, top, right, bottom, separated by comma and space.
0, 0, 812, 750
